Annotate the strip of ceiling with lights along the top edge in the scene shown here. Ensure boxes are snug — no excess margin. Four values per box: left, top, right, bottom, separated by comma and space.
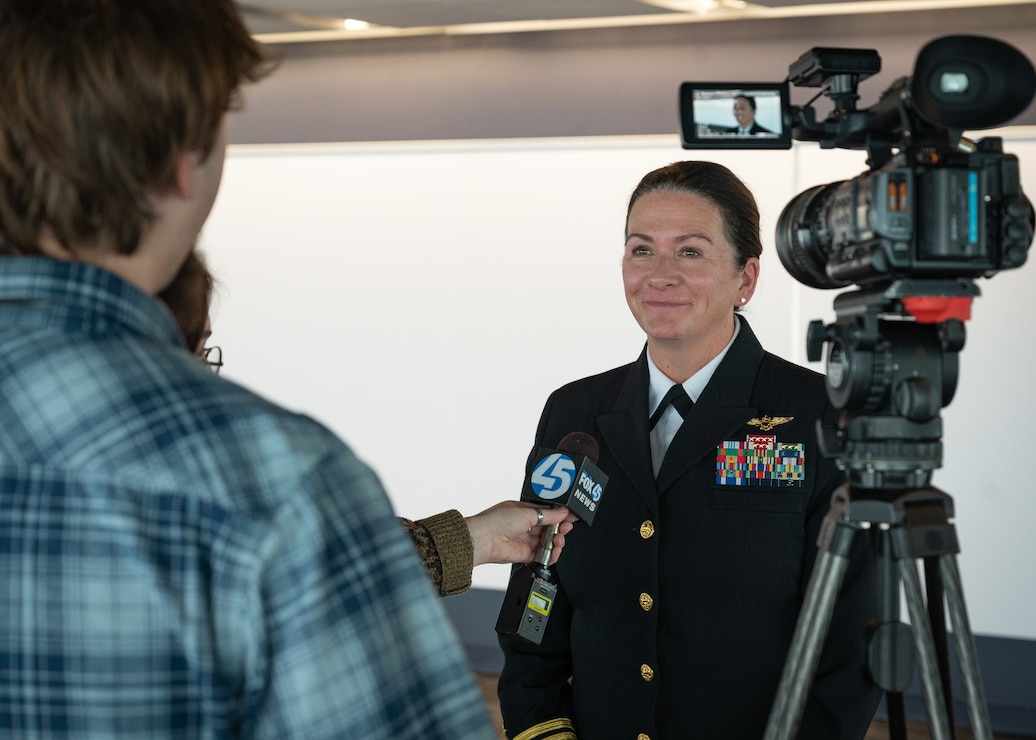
238, 0, 1034, 42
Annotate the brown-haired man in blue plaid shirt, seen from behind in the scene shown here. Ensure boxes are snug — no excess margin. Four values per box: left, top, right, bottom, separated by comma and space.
0, 0, 494, 740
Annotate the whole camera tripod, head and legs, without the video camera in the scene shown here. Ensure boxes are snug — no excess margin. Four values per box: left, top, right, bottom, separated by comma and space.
765, 280, 991, 740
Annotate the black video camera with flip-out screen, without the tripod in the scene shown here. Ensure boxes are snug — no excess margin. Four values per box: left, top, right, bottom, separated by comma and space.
681, 36, 1036, 288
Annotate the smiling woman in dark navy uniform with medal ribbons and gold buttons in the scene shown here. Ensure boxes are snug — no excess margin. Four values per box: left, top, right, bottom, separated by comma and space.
498, 162, 880, 740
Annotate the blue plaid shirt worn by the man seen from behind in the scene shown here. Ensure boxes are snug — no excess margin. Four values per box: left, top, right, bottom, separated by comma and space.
0, 257, 496, 740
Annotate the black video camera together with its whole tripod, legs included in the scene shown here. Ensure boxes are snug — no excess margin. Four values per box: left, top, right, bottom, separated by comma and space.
680, 36, 1036, 740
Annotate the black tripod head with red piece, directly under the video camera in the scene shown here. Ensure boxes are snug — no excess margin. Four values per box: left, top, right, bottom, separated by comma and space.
806, 279, 979, 499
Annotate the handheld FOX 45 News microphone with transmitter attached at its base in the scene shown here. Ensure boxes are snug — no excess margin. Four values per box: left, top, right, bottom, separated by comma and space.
496, 432, 608, 645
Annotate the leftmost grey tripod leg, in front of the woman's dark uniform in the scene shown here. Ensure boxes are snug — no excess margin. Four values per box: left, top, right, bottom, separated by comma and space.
764, 524, 854, 740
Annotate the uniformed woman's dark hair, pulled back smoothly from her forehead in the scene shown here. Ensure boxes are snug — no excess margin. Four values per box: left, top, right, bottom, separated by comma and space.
626, 161, 762, 269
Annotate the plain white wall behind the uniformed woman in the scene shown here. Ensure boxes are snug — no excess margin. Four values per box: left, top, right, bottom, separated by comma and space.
201, 129, 1036, 638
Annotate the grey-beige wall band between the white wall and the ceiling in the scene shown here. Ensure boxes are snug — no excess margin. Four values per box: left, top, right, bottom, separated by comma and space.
230, 4, 1036, 144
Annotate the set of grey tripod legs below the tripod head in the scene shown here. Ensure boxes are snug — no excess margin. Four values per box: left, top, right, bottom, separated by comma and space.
765, 483, 992, 740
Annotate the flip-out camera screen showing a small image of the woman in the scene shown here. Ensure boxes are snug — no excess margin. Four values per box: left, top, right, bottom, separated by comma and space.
680, 82, 792, 149
